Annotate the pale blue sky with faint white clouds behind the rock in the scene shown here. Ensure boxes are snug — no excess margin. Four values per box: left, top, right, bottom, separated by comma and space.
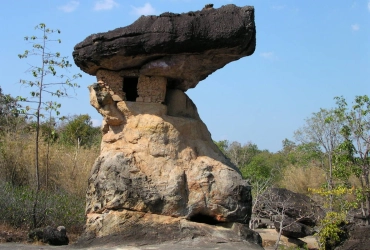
0, 0, 370, 152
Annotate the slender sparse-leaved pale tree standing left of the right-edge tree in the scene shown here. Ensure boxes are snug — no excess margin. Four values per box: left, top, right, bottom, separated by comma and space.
294, 109, 342, 211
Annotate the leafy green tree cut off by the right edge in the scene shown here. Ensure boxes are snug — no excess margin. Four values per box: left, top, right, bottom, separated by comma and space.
335, 95, 370, 224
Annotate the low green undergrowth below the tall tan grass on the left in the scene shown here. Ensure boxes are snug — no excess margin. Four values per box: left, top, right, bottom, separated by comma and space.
0, 182, 85, 228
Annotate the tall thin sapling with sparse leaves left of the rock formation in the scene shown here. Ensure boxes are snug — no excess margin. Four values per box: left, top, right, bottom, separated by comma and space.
18, 23, 81, 227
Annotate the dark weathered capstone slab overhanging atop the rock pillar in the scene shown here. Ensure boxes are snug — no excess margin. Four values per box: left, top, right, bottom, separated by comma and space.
73, 5, 256, 91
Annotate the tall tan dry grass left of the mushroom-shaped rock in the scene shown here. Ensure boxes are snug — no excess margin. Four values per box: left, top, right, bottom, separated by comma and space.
0, 131, 100, 197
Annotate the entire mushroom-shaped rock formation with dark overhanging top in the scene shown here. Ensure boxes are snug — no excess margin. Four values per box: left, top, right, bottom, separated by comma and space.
73, 5, 259, 248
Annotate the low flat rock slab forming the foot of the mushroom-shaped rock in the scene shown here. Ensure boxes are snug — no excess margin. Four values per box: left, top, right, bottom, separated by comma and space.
76, 210, 263, 249
